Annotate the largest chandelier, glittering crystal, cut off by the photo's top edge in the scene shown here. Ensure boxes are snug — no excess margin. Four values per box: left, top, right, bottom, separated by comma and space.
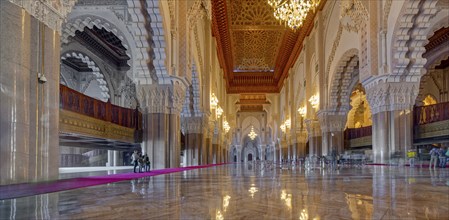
268, 0, 320, 30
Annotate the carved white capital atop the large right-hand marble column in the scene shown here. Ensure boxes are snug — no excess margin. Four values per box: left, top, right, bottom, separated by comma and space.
363, 76, 419, 115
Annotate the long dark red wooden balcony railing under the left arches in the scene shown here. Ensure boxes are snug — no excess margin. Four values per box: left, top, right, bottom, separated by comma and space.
59, 85, 142, 130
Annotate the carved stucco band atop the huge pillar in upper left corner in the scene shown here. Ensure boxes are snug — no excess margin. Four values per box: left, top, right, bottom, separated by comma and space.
9, 0, 77, 32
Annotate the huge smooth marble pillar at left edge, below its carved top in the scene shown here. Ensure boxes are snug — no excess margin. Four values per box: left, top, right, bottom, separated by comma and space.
0, 1, 60, 185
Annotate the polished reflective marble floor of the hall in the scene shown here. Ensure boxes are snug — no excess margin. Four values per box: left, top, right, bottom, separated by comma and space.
0, 164, 449, 219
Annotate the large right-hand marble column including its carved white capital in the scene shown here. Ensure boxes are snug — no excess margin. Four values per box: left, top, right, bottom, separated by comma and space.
364, 81, 419, 163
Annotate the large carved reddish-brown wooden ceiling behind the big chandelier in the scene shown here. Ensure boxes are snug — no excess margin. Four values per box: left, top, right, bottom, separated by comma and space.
212, 0, 326, 93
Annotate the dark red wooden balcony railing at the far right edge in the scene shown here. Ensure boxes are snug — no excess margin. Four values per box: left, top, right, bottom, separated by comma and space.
413, 102, 449, 125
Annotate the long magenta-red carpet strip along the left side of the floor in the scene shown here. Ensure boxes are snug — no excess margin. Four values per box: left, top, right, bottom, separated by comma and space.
0, 164, 223, 200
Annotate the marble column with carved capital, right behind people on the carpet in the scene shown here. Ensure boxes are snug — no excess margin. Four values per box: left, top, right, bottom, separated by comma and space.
137, 83, 185, 169
